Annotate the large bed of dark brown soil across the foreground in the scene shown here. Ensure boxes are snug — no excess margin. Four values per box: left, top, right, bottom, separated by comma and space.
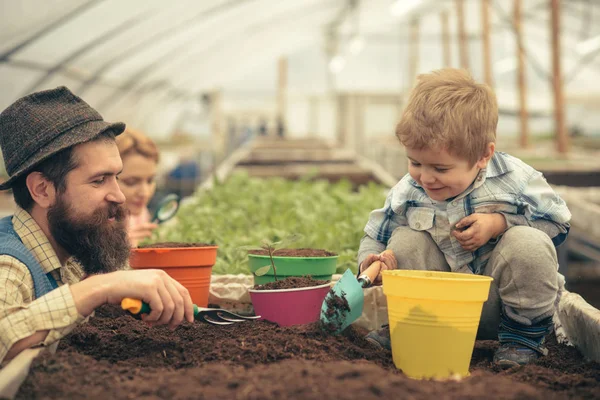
17, 307, 600, 400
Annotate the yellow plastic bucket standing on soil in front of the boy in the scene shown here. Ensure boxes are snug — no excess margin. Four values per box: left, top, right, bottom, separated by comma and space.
383, 270, 493, 379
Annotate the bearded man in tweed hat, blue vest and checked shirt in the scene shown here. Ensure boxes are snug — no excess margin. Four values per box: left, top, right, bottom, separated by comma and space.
0, 87, 193, 362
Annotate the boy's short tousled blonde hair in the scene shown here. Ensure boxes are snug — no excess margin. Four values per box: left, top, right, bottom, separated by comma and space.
396, 68, 498, 165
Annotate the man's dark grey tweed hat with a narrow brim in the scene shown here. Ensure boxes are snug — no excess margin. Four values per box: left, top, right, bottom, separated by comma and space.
0, 86, 125, 190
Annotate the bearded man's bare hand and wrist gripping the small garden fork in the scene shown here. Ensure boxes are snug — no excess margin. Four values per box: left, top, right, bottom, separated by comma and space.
71, 269, 194, 329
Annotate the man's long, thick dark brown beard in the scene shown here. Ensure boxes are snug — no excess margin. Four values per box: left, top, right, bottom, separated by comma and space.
48, 195, 130, 275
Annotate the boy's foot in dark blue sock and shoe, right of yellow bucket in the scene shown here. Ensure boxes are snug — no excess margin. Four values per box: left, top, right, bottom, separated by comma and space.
494, 313, 552, 368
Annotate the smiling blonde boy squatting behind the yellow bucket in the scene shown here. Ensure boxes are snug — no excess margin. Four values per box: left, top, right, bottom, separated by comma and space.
358, 68, 571, 368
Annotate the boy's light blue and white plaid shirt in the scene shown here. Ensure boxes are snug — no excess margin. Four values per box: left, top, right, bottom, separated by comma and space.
365, 152, 571, 274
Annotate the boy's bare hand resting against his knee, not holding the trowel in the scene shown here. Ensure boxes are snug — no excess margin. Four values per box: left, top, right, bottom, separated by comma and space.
452, 213, 506, 252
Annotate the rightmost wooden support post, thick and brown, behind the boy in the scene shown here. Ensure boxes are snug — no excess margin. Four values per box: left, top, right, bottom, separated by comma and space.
550, 0, 569, 154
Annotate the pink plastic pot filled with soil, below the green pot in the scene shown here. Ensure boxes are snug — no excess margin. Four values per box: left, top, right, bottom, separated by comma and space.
248, 283, 331, 326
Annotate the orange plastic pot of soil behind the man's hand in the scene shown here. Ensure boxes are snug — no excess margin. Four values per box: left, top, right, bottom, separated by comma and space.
129, 246, 218, 307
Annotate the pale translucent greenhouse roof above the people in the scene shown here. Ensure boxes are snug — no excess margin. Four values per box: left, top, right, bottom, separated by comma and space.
0, 0, 600, 136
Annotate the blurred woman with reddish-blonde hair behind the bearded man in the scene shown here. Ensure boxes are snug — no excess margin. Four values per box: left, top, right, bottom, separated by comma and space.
116, 128, 159, 247
